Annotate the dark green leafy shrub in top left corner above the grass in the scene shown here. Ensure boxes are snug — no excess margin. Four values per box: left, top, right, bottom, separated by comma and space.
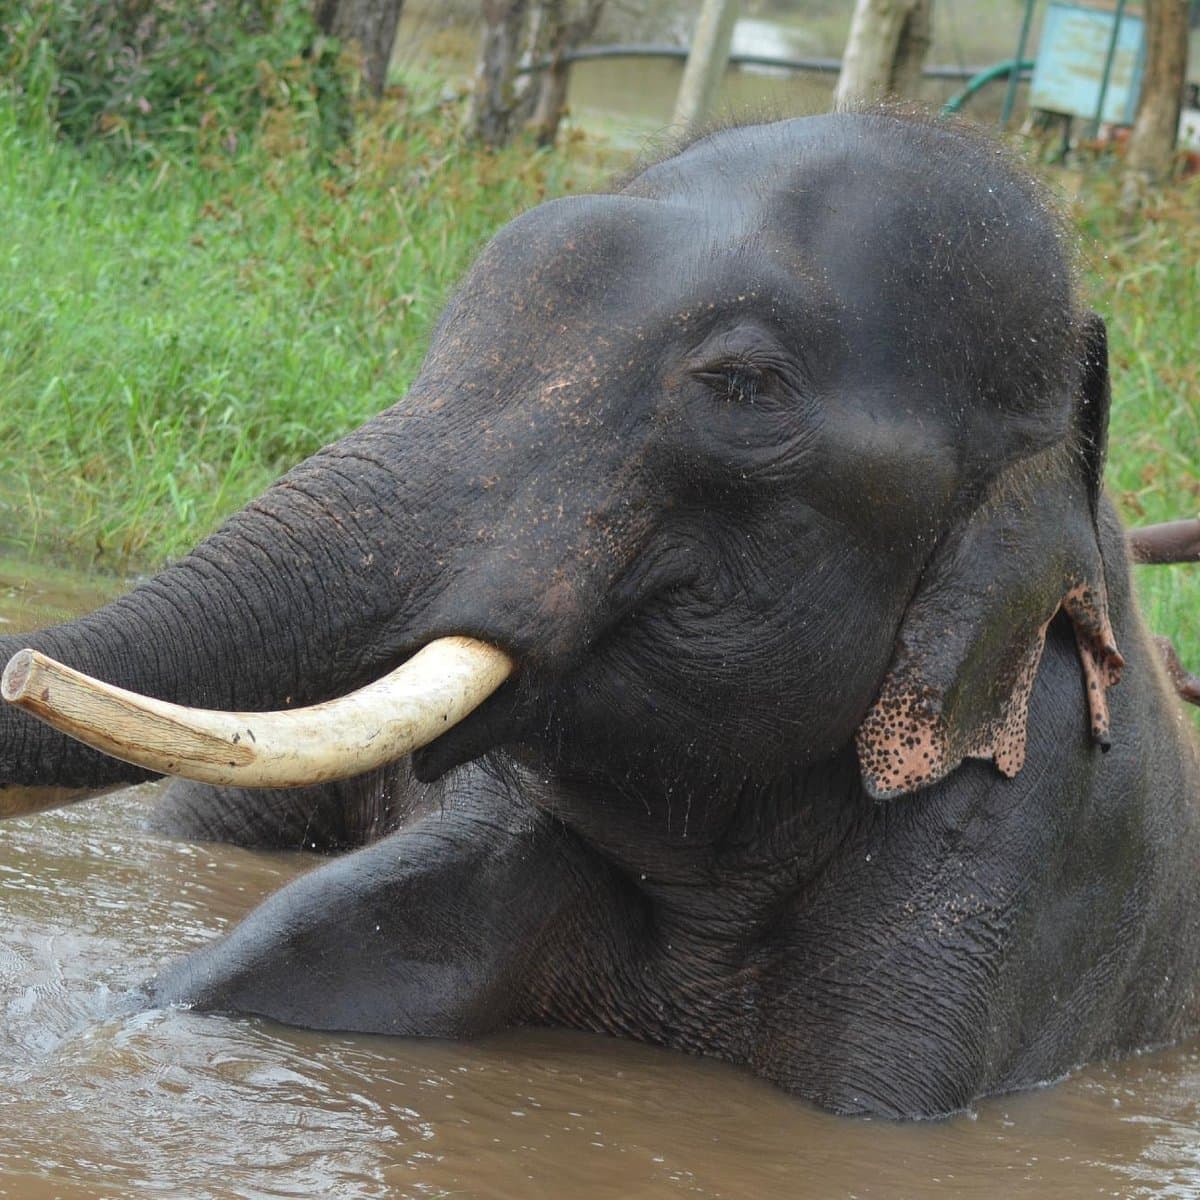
0, 0, 349, 160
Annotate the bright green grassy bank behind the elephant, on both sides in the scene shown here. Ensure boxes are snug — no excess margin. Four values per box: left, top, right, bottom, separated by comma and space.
0, 92, 1200, 665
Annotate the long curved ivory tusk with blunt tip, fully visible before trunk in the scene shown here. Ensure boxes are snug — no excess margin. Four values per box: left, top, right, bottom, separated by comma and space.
0, 637, 514, 787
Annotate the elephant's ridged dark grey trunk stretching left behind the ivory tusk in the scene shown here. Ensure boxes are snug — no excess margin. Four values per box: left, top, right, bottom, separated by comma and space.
0, 419, 489, 815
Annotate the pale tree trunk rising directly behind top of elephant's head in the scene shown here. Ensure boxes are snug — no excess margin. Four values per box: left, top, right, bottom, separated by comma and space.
834, 0, 932, 108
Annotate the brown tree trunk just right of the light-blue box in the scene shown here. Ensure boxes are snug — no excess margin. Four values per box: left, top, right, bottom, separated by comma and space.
1126, 0, 1188, 182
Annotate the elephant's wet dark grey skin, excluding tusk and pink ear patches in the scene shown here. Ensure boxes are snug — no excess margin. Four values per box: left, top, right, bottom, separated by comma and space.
0, 115, 1200, 1116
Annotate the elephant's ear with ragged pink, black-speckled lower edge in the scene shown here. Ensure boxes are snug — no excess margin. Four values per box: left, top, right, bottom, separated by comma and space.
857, 317, 1123, 799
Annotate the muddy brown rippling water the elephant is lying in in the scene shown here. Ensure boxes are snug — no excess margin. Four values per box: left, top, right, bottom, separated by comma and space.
0, 564, 1200, 1200
